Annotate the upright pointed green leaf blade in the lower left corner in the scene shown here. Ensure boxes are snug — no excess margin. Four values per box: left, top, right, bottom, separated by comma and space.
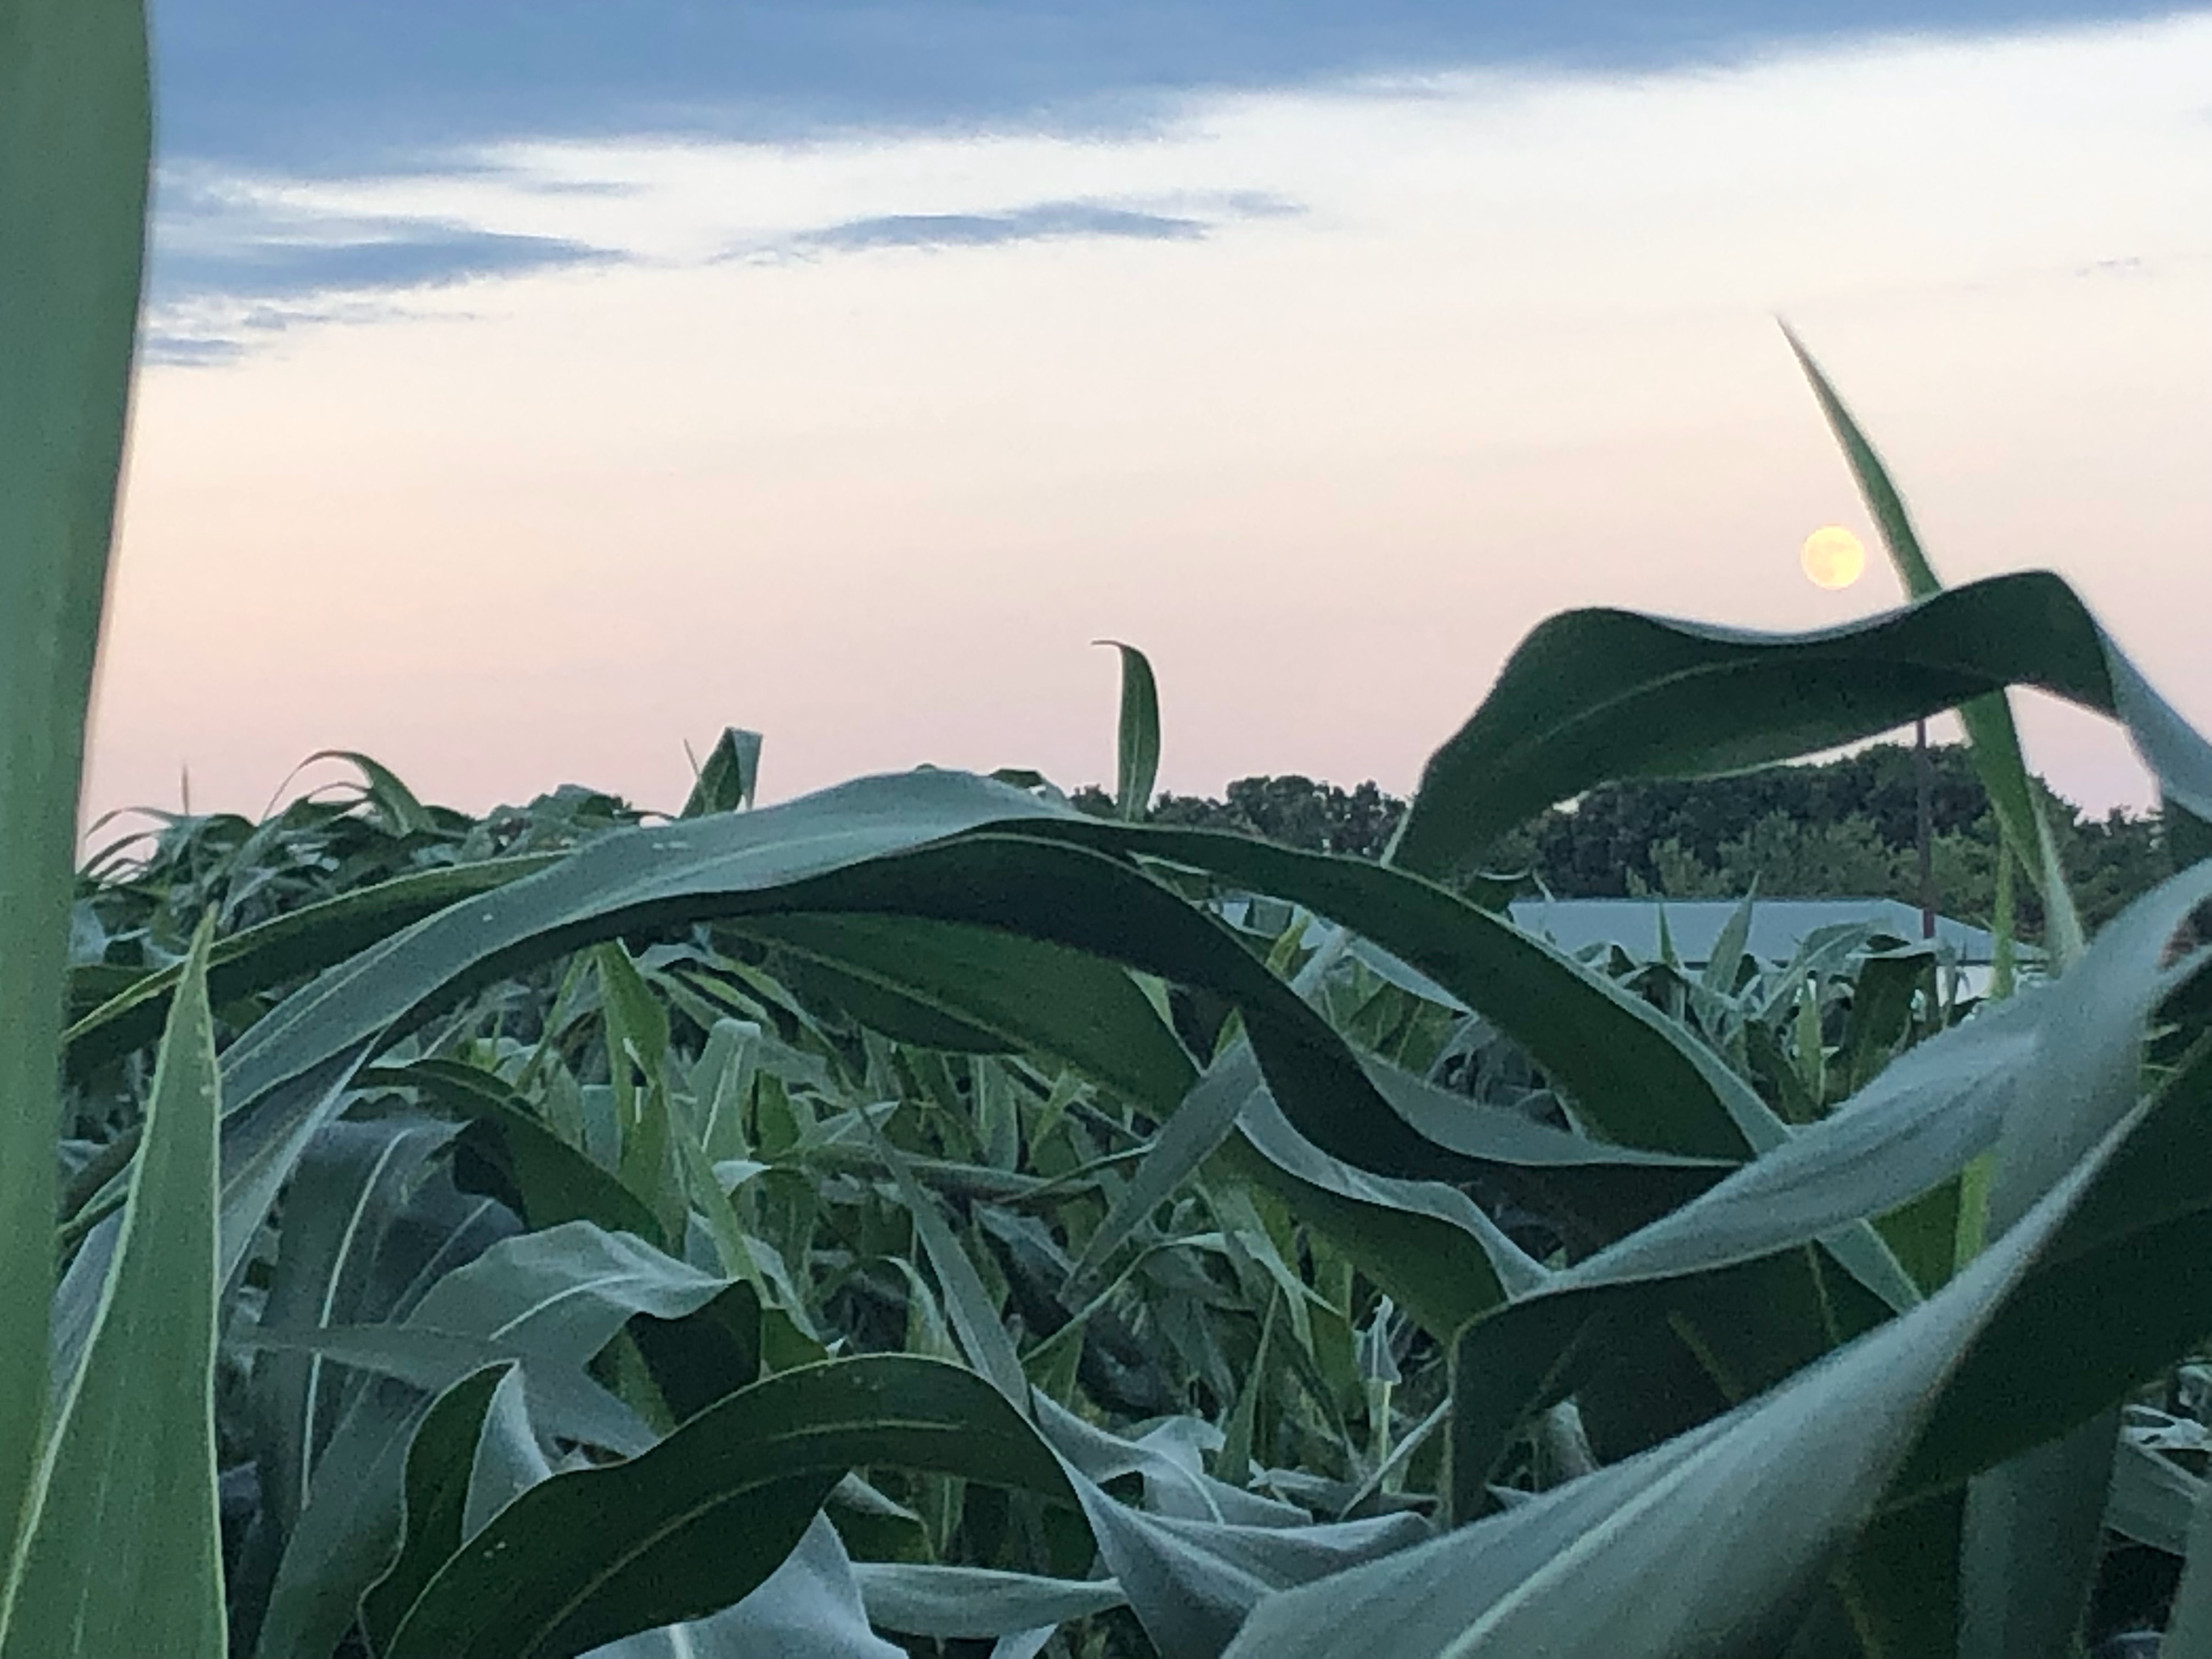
0, 922, 228, 1659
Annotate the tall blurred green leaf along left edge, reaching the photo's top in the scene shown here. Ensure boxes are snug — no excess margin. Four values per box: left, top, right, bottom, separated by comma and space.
0, 0, 153, 1548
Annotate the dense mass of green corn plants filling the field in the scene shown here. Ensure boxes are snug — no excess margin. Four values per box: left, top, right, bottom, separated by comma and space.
21, 0, 2212, 1659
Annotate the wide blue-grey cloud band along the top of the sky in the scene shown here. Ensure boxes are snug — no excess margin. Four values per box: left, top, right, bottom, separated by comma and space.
157, 0, 2176, 168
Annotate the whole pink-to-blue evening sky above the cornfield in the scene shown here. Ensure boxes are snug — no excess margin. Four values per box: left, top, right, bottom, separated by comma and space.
86, 0, 2212, 832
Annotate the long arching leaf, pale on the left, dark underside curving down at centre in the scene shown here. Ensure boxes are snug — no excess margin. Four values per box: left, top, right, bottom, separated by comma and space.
216, 774, 1539, 1248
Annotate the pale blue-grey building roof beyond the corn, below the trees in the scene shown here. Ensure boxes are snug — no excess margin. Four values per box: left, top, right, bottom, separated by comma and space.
1513, 898, 1995, 967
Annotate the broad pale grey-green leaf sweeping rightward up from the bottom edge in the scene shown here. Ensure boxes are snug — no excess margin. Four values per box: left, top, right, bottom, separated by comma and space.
1221, 1092, 2126, 1659
